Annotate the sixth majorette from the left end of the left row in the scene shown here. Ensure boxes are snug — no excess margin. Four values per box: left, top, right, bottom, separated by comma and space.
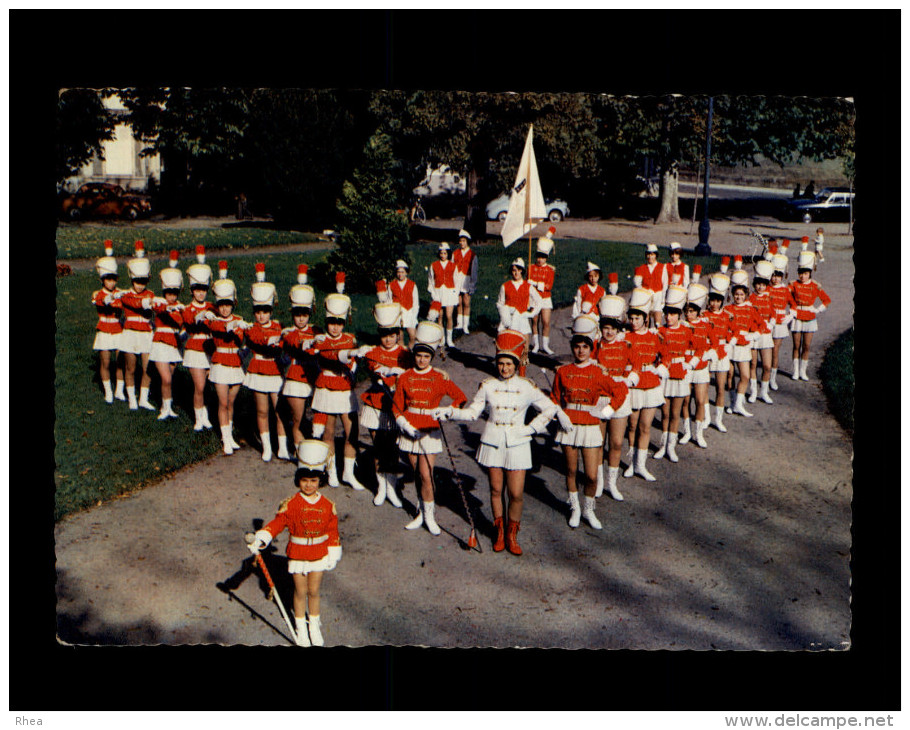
243, 263, 291, 461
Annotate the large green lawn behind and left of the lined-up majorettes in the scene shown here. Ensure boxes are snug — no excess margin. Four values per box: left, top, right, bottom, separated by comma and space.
54, 236, 719, 520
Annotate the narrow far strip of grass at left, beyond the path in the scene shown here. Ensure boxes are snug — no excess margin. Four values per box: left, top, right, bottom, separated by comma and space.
57, 228, 321, 260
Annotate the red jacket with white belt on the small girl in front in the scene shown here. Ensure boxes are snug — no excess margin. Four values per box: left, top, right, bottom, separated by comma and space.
262, 492, 341, 561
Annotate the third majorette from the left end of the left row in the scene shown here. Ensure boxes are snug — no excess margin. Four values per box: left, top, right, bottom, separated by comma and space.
149, 251, 183, 421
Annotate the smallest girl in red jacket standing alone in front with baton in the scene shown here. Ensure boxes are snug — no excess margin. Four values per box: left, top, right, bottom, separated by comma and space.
249, 439, 342, 646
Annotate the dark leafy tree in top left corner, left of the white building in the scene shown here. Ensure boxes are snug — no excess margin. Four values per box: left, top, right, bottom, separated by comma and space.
56, 89, 116, 183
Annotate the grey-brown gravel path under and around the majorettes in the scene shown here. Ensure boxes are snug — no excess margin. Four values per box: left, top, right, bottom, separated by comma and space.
55, 213, 854, 650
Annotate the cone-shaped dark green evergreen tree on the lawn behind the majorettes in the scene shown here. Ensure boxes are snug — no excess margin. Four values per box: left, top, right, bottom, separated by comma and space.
329, 133, 408, 292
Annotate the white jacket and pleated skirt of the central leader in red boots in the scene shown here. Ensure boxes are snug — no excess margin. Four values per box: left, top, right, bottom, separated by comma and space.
452, 375, 556, 470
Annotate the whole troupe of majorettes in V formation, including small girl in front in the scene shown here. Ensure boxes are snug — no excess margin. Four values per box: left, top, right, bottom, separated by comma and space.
92, 228, 831, 645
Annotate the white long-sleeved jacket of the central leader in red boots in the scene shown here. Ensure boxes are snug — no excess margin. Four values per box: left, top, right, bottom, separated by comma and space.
451, 375, 557, 448
